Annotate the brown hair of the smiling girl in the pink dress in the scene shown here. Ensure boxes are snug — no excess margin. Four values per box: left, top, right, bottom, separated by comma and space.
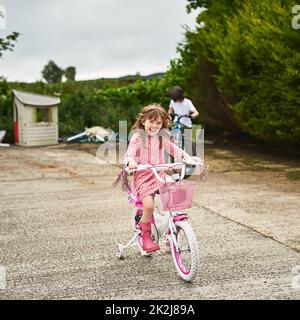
132, 103, 170, 149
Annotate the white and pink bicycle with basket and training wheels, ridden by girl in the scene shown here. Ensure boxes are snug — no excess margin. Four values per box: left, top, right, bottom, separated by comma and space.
117, 157, 205, 281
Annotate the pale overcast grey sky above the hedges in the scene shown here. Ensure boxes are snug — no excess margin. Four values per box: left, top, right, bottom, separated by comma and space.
0, 0, 202, 81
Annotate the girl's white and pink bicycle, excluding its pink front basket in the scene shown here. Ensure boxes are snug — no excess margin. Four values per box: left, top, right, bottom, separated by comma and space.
117, 163, 202, 281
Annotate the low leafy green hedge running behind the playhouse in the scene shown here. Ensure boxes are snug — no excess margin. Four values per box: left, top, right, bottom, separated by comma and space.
0, 69, 180, 142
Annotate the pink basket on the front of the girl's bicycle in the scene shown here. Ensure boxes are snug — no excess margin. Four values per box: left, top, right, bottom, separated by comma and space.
159, 181, 196, 211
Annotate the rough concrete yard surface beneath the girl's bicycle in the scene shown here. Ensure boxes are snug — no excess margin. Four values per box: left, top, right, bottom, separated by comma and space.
0, 144, 300, 299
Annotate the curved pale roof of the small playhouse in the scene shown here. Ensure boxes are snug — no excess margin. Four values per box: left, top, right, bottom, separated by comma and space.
13, 90, 60, 107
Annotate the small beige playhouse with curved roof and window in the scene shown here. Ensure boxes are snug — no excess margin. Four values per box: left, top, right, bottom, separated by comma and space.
13, 90, 60, 146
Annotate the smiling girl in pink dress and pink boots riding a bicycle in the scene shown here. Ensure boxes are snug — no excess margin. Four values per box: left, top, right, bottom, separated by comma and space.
116, 104, 191, 252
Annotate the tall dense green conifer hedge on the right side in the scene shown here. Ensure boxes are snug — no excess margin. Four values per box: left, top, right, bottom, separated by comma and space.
173, 0, 300, 146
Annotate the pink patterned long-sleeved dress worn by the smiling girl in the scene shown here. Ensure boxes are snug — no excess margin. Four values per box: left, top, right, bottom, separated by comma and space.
124, 133, 189, 199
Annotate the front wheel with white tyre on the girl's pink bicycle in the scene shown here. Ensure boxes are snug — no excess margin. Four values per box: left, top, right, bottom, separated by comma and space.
171, 221, 199, 282
